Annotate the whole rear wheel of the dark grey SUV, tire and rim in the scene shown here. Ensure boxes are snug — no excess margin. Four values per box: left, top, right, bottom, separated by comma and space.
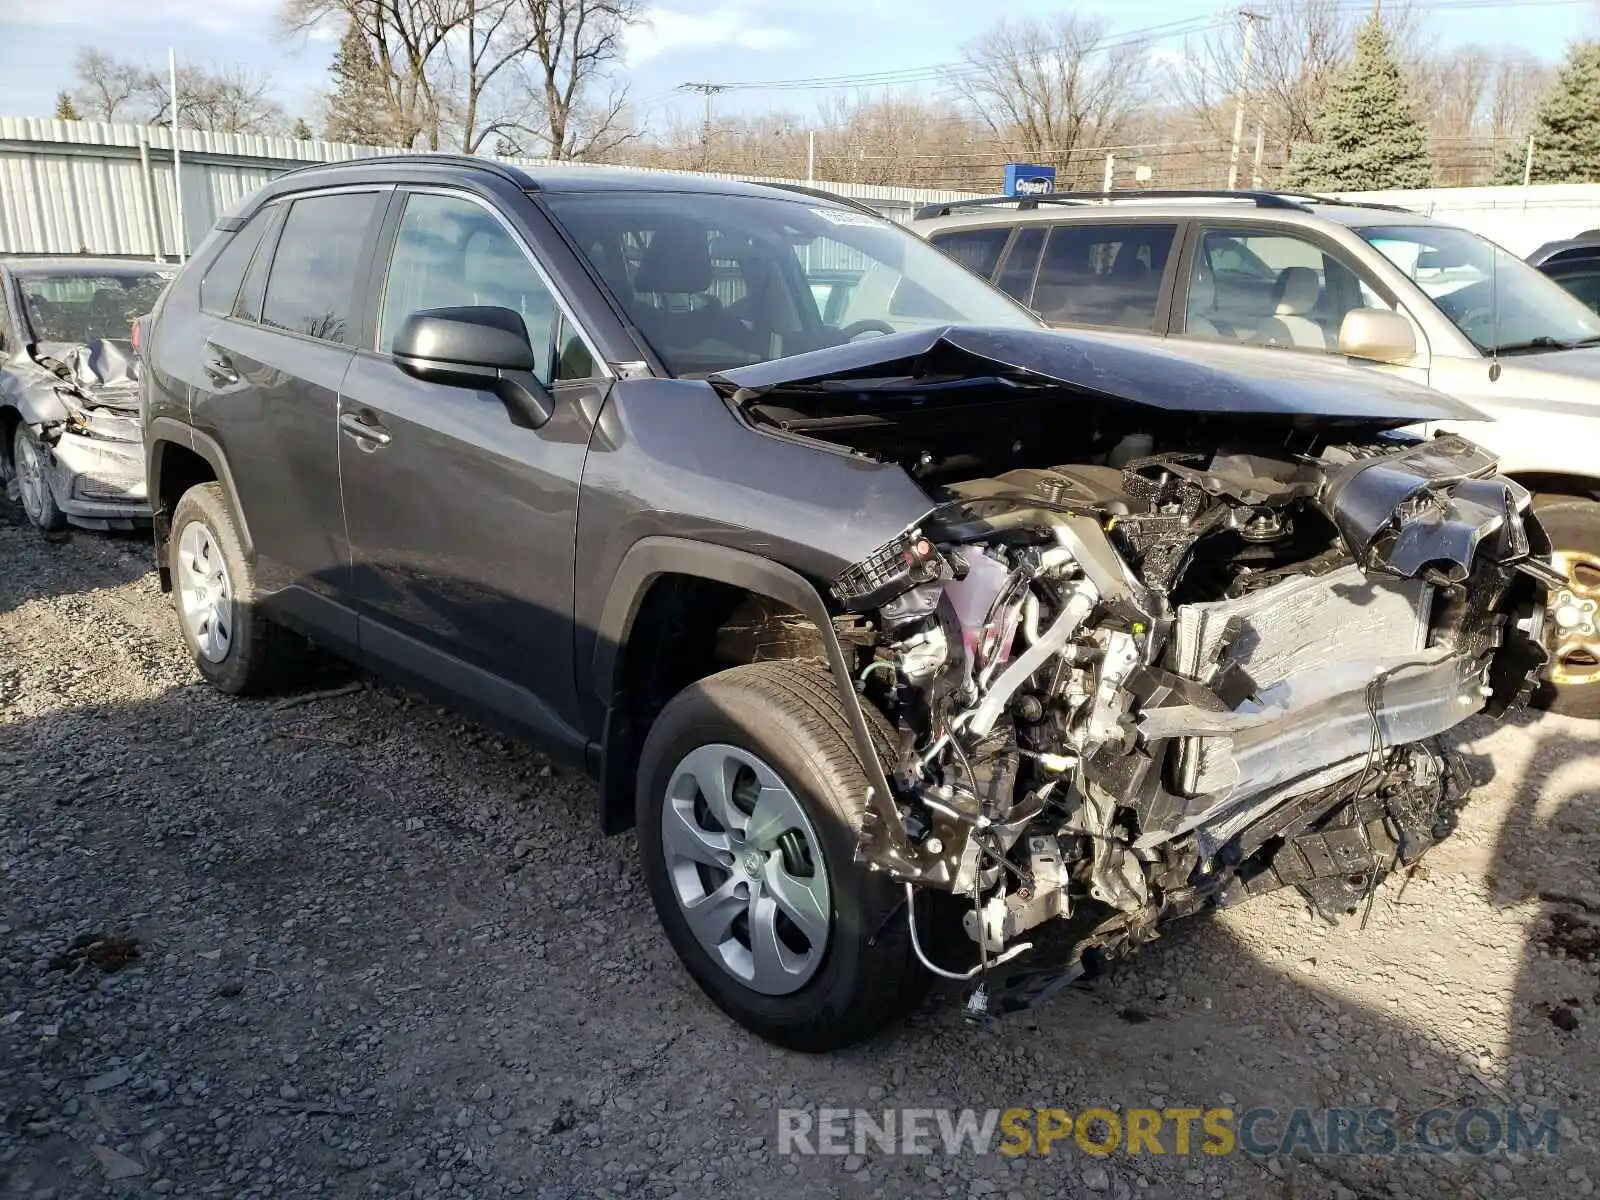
166, 483, 307, 696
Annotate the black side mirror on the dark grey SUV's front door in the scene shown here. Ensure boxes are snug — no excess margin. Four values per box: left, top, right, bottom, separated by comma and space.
392, 306, 555, 429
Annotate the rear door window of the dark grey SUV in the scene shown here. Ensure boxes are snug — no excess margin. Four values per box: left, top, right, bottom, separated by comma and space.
261, 192, 379, 344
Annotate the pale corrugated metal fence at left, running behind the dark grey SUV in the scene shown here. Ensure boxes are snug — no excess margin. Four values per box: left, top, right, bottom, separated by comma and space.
0, 117, 968, 258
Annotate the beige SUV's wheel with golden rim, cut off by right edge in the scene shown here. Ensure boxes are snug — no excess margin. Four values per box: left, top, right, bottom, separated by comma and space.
1534, 496, 1600, 718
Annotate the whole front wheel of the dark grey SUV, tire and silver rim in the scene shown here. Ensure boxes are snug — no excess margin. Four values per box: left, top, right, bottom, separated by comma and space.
638, 661, 926, 1051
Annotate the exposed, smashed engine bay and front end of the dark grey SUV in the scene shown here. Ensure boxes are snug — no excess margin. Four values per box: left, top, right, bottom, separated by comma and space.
716, 329, 1554, 1016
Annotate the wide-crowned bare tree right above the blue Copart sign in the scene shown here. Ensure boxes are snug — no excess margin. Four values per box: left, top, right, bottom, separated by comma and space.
949, 13, 1147, 181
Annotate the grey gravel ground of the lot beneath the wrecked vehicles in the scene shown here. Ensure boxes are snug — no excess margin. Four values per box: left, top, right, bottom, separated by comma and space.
0, 501, 1600, 1200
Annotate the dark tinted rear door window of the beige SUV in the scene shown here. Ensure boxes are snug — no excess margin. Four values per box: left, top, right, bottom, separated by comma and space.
1034, 222, 1178, 331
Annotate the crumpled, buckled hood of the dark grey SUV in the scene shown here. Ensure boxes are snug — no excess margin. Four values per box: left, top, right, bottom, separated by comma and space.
710, 325, 1483, 429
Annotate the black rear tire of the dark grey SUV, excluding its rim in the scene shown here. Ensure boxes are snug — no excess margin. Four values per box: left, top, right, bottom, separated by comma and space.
166, 483, 309, 696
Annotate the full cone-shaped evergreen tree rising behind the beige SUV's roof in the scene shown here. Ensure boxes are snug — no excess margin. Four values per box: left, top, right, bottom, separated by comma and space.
1285, 14, 1434, 192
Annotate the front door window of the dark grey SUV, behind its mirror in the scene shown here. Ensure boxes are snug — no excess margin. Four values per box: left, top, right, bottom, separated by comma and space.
378, 194, 560, 382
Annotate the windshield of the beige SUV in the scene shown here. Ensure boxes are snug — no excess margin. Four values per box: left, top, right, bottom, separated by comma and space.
1357, 226, 1600, 354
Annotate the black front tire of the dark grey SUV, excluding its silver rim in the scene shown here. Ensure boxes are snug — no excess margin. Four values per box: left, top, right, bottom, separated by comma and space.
638, 661, 928, 1053
